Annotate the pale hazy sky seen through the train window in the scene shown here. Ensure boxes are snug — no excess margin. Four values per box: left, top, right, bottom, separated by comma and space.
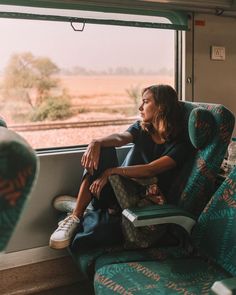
0, 19, 174, 72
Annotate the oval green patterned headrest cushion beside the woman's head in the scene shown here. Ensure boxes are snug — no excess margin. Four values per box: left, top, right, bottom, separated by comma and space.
188, 107, 215, 149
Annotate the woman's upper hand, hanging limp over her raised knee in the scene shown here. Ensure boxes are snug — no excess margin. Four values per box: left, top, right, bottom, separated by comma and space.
81, 141, 101, 175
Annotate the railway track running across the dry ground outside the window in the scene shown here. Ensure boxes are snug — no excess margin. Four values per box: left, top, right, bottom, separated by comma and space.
8, 117, 137, 131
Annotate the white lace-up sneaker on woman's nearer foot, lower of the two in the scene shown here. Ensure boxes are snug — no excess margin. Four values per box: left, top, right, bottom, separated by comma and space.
49, 215, 80, 249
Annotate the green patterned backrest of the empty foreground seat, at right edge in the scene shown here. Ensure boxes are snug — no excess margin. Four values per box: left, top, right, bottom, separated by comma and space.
192, 168, 236, 276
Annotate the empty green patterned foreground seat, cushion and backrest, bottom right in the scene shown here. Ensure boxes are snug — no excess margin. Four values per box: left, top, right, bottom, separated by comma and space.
94, 168, 236, 295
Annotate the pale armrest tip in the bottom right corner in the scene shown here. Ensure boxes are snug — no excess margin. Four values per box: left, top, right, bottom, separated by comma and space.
211, 277, 236, 295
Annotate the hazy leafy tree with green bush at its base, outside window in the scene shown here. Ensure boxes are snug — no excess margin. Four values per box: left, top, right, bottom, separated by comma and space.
2, 52, 72, 121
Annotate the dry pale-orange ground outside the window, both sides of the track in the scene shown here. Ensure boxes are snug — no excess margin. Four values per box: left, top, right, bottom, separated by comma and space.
0, 75, 173, 148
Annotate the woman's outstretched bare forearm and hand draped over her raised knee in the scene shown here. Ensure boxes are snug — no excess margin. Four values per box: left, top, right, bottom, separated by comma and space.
81, 131, 133, 174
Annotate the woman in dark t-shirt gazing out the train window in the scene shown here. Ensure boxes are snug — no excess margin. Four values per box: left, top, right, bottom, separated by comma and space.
50, 85, 187, 249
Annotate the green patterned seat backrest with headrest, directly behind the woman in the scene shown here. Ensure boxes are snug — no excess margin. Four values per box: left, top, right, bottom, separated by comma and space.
170, 102, 235, 217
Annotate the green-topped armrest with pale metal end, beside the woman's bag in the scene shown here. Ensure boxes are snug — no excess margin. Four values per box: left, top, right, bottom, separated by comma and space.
122, 204, 196, 233
